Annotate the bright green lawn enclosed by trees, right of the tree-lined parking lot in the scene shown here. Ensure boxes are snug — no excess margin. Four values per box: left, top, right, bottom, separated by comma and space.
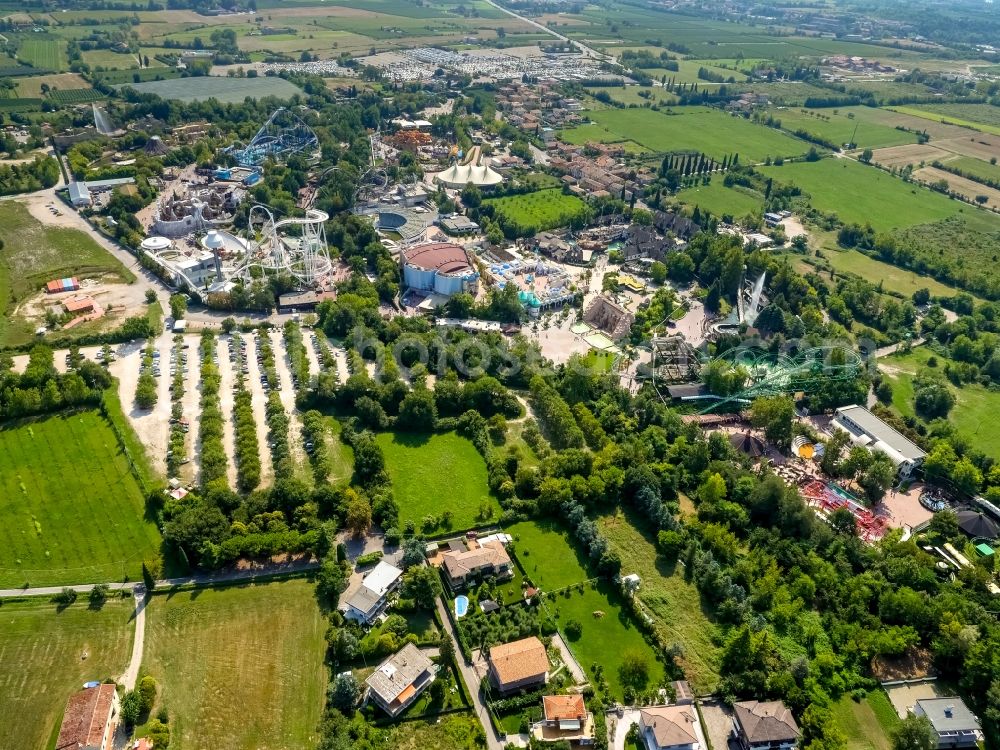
376, 432, 500, 530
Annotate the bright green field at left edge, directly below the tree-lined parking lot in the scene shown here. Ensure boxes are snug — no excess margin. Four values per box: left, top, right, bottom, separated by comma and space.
0, 411, 160, 587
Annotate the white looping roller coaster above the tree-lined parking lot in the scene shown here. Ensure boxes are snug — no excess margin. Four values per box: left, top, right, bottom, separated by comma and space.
233, 205, 333, 286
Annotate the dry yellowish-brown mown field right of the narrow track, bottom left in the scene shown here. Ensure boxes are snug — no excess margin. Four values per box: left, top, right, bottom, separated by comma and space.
142, 579, 328, 750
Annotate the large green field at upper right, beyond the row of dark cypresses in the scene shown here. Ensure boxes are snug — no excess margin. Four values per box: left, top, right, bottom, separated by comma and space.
761, 159, 977, 231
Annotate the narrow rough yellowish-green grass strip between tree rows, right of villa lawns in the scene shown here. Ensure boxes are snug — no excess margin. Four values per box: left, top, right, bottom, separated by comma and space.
598, 514, 719, 693
